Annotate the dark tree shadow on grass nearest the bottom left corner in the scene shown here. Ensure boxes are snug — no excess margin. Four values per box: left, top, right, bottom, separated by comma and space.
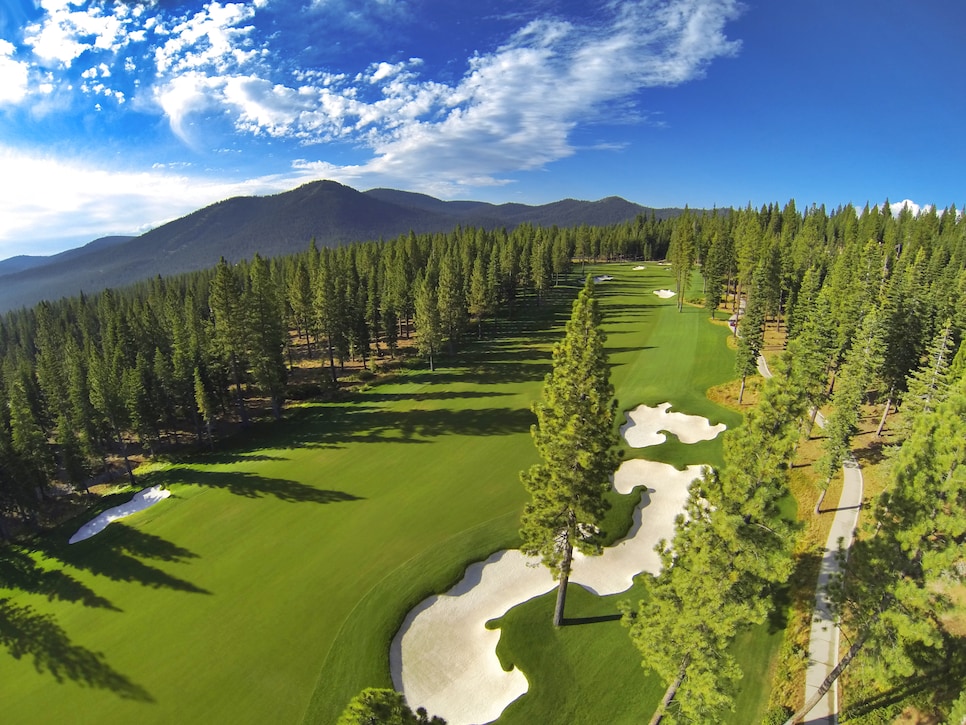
0, 599, 154, 702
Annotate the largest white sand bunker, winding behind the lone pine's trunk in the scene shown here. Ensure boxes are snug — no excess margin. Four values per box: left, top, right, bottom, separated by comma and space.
389, 459, 702, 725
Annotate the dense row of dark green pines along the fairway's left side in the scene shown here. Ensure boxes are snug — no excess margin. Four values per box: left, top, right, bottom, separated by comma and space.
0, 214, 670, 537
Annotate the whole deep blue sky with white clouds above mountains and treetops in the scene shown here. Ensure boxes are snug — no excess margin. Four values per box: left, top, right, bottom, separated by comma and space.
0, 0, 966, 258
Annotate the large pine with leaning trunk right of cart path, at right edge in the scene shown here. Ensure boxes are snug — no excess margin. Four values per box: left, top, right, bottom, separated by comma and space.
786, 368, 966, 725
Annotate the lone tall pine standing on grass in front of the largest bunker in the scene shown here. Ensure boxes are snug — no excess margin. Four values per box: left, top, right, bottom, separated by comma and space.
520, 279, 620, 626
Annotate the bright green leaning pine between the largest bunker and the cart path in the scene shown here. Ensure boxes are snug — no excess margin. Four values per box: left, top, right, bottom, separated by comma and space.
621, 355, 805, 723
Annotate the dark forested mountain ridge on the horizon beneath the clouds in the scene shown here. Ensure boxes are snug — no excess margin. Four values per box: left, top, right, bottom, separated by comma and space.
0, 181, 680, 311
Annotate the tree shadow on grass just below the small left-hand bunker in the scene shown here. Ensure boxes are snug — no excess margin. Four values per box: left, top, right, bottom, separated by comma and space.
31, 521, 211, 594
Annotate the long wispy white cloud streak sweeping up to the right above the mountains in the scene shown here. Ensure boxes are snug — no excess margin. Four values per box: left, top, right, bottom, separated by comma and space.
276, 0, 739, 194
